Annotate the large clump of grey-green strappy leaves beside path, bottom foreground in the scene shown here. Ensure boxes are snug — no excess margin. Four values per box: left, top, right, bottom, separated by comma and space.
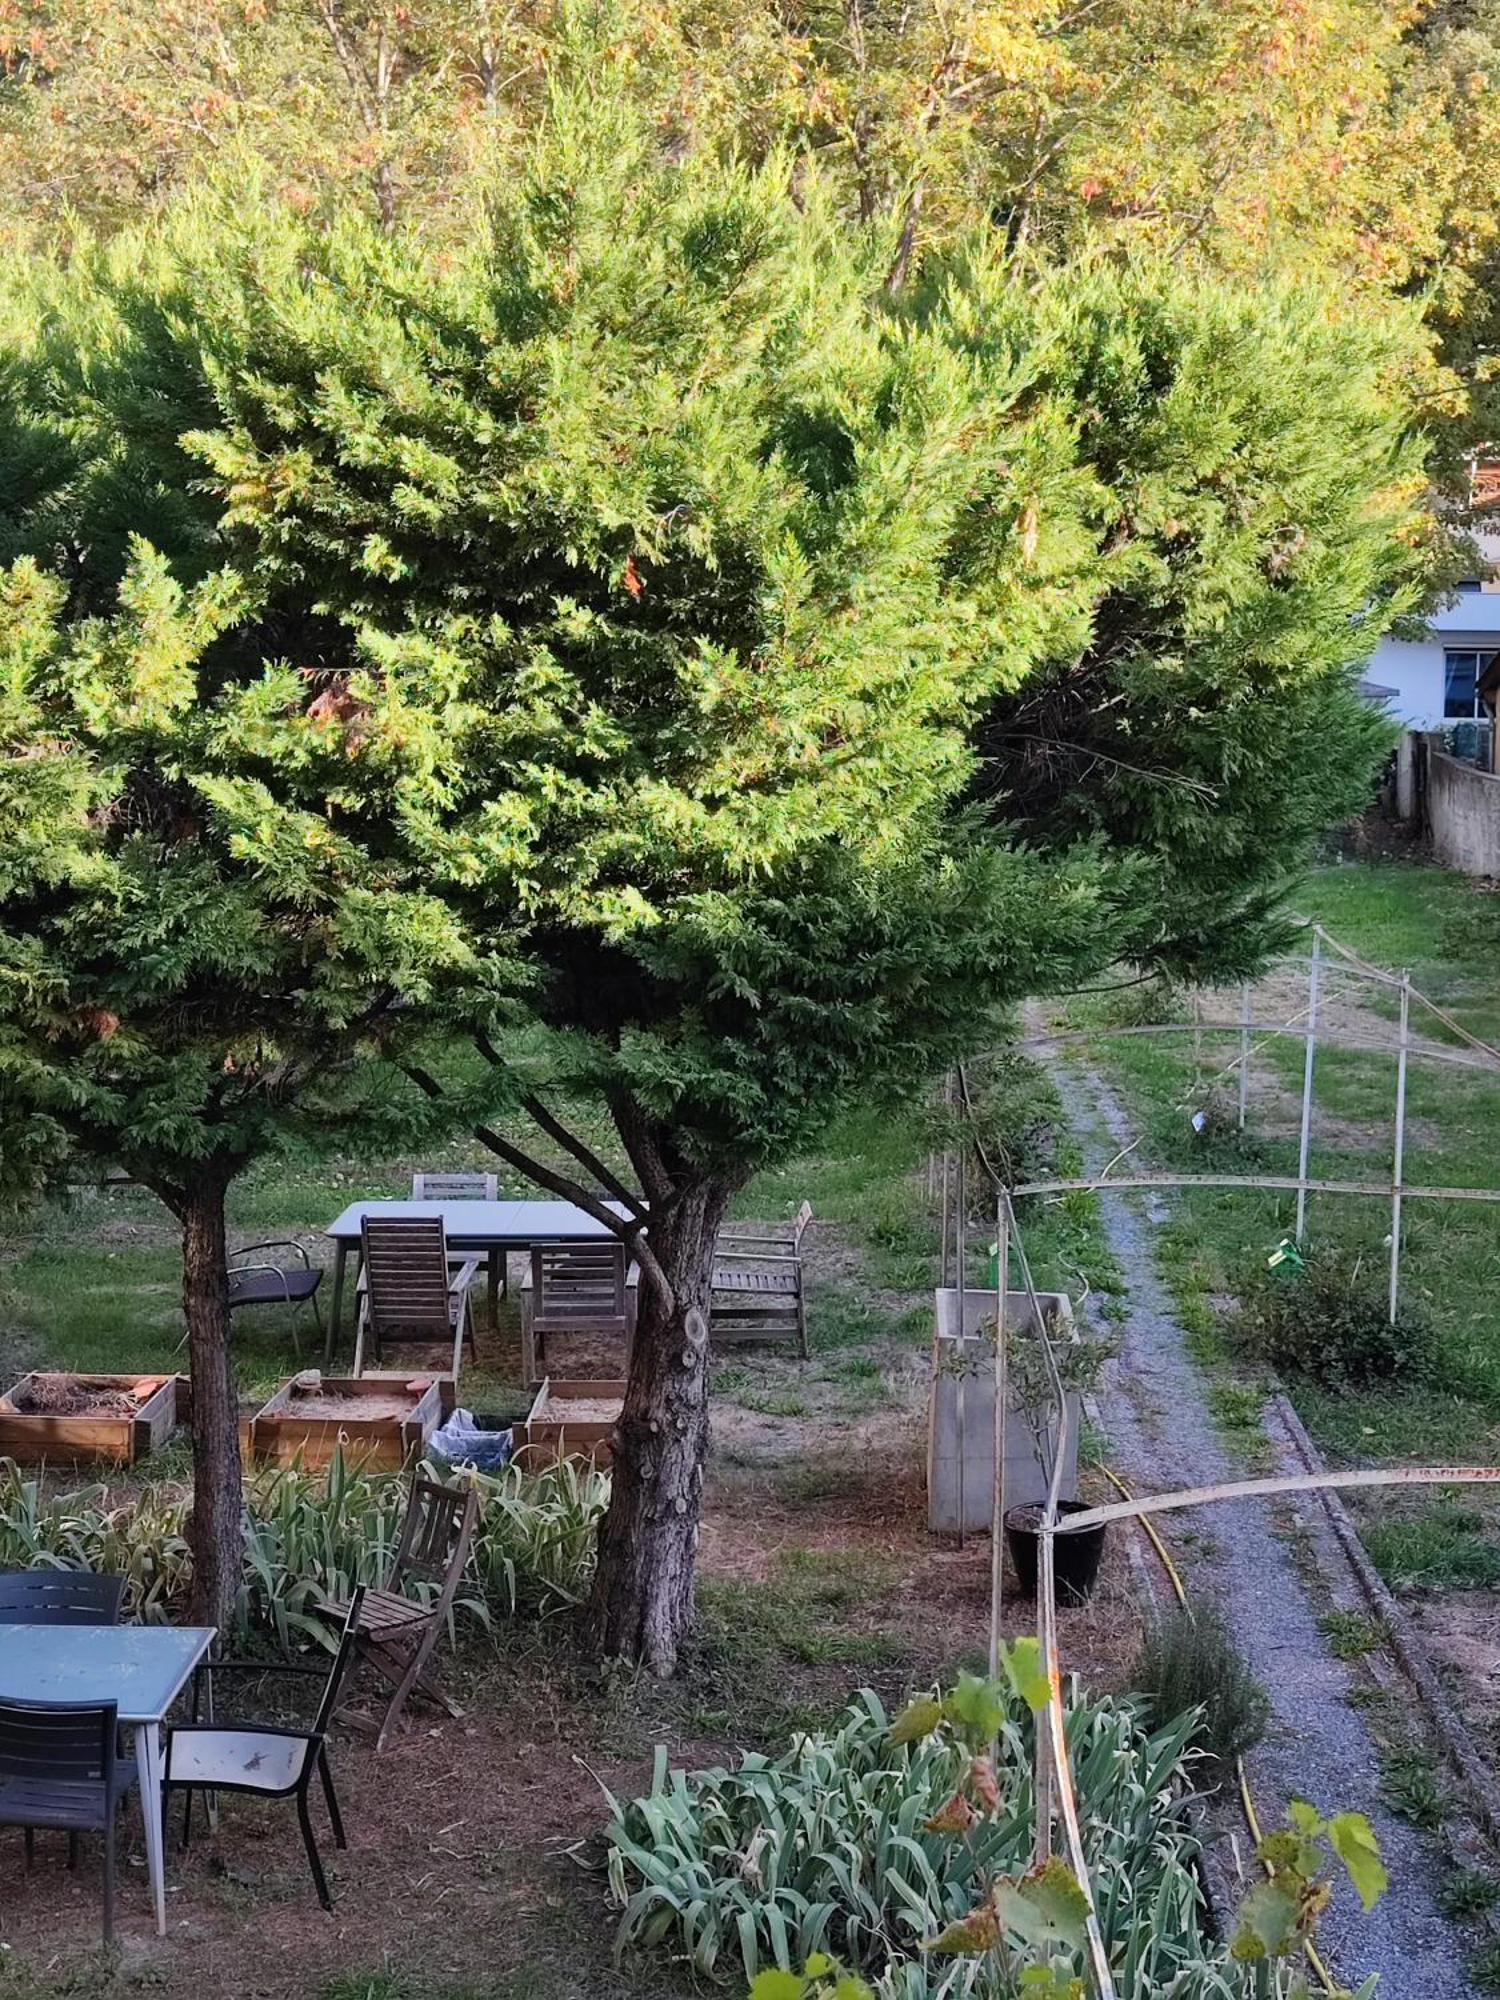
608, 1684, 1236, 2000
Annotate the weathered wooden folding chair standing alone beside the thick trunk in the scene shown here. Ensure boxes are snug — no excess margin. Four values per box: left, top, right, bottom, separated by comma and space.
322, 1478, 480, 1750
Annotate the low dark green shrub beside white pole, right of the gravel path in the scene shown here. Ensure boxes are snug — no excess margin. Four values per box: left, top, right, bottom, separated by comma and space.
1238, 1248, 1436, 1388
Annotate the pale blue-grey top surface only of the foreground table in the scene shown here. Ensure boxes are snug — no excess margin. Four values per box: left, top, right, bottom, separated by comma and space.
0, 1624, 218, 1722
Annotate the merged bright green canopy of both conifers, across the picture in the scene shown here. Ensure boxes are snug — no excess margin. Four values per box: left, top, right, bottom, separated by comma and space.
0, 66, 1448, 1666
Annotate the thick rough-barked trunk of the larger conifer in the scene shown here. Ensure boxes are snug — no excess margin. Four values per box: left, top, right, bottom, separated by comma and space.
590, 1180, 730, 1674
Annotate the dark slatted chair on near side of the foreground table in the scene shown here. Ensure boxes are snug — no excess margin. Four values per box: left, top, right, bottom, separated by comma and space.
0, 1700, 136, 1944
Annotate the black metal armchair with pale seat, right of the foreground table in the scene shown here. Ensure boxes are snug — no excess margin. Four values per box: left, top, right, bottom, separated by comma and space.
162, 1588, 364, 1910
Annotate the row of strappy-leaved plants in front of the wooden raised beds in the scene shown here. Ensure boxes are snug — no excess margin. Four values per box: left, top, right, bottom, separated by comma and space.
0, 1456, 608, 1652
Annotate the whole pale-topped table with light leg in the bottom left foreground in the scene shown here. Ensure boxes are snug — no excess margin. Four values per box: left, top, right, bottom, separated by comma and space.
0, 1624, 218, 1938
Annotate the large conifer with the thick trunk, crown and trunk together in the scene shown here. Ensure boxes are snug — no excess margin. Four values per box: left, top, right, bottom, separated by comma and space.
0, 90, 1420, 1670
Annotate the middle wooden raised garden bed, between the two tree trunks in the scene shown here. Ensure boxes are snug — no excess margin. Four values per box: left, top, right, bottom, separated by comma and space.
240, 1370, 442, 1468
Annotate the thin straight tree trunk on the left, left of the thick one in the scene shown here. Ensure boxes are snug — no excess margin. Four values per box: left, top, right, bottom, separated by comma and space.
180, 1174, 244, 1638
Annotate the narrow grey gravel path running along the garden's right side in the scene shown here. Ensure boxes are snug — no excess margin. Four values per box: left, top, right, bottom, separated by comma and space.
1054, 1064, 1474, 2000
